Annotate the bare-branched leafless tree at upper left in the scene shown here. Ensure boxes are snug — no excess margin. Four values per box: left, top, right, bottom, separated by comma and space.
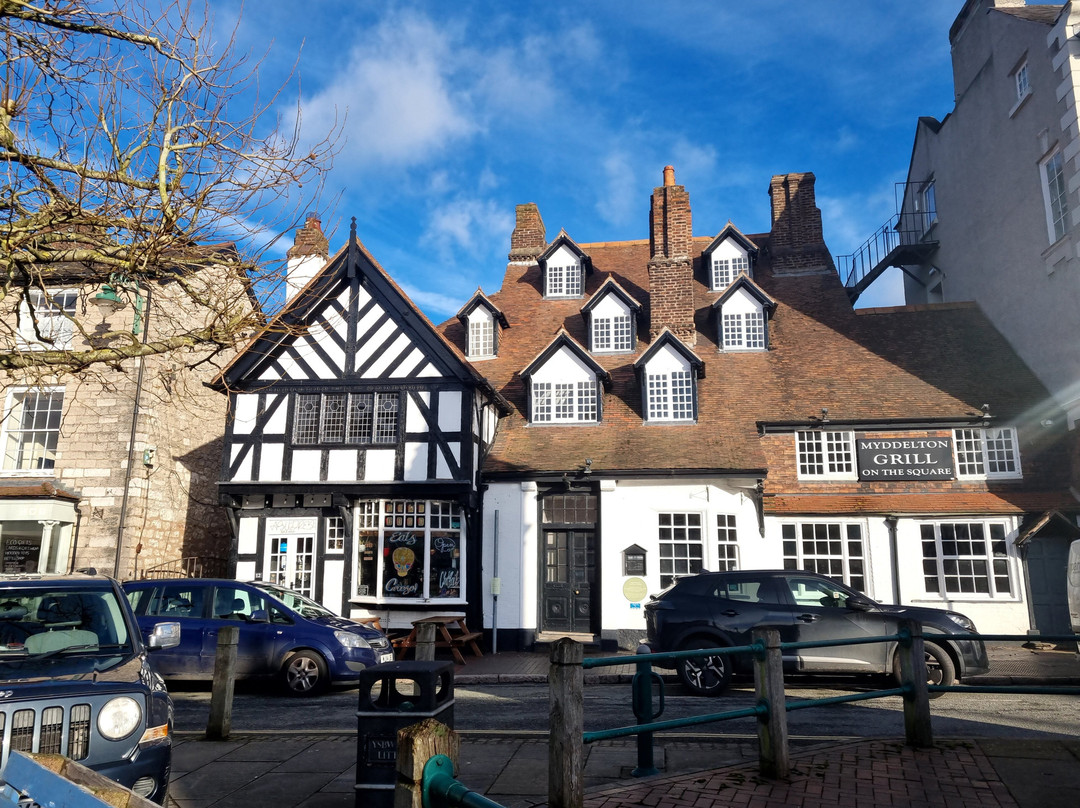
0, 0, 335, 378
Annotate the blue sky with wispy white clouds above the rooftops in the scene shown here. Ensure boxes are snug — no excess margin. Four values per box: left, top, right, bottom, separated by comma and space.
214, 0, 962, 322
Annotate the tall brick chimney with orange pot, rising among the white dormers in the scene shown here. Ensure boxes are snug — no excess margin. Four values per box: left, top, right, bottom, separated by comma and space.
649, 165, 698, 346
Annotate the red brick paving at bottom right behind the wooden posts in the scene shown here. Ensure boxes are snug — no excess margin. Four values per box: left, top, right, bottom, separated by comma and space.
585, 741, 1017, 808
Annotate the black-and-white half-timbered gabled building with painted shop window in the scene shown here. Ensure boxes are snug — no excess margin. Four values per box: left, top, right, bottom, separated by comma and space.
216, 216, 504, 628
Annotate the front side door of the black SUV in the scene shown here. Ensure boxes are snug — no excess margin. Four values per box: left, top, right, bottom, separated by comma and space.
784, 575, 889, 673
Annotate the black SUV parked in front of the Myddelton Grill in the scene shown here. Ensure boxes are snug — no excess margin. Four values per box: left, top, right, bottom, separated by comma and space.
645, 569, 989, 696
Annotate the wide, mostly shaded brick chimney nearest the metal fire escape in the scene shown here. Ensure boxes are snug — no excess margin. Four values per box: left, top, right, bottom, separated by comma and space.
769, 173, 836, 274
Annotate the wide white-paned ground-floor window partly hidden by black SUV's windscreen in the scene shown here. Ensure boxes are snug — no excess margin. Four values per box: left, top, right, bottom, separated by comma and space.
780, 522, 867, 592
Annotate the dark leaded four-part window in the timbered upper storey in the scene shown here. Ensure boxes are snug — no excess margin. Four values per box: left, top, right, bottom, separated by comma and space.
293, 392, 399, 445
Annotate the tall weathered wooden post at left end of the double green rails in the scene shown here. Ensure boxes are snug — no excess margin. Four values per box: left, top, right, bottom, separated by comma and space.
548, 637, 585, 808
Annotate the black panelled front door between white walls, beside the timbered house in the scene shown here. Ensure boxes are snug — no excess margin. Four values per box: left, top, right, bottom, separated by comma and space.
541, 529, 596, 633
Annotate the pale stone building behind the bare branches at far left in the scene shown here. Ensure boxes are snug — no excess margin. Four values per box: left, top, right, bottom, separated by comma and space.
0, 262, 243, 579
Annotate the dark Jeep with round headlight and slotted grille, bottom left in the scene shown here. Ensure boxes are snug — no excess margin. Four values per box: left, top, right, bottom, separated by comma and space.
0, 575, 180, 803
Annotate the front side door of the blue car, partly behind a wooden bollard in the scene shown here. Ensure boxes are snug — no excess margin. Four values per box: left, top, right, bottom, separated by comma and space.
201, 583, 280, 676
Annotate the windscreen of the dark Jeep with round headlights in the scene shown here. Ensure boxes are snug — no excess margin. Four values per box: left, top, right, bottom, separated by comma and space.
0, 587, 131, 661
